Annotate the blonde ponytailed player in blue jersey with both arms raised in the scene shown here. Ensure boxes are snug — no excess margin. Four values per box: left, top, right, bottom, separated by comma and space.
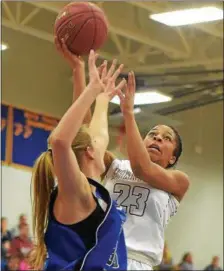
29, 51, 127, 270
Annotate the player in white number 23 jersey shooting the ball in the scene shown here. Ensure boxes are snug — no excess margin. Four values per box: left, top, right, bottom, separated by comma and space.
55, 41, 189, 270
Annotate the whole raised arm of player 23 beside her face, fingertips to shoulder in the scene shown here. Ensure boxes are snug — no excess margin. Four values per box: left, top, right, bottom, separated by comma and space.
120, 72, 189, 200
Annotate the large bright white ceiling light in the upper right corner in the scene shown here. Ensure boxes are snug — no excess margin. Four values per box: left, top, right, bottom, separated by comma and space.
150, 7, 223, 26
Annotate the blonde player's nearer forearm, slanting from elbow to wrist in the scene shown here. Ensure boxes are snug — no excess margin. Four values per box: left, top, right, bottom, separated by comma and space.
51, 85, 97, 146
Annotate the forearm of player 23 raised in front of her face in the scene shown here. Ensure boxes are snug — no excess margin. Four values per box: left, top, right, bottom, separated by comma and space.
124, 113, 151, 172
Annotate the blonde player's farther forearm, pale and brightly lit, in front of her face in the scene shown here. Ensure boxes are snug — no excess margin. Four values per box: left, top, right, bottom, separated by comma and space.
90, 95, 109, 142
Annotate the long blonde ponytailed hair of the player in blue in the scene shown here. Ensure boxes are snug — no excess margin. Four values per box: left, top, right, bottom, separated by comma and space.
30, 125, 92, 270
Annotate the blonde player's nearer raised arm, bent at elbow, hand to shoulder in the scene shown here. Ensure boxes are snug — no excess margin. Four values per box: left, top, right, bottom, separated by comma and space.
50, 51, 104, 202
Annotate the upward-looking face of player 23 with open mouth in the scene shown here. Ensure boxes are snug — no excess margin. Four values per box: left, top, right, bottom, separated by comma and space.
144, 125, 176, 168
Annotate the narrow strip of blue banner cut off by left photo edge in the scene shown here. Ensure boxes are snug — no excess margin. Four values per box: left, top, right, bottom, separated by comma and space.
1, 104, 9, 161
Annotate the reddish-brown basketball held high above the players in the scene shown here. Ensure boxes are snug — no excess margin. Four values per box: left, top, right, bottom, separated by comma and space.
54, 2, 108, 55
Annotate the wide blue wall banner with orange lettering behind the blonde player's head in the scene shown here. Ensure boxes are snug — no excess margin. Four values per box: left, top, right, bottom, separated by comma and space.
12, 109, 58, 167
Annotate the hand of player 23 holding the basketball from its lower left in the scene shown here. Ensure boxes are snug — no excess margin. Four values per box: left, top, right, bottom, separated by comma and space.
54, 36, 85, 70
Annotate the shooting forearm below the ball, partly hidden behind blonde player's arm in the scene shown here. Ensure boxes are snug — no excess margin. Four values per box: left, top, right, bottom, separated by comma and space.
72, 68, 92, 124
